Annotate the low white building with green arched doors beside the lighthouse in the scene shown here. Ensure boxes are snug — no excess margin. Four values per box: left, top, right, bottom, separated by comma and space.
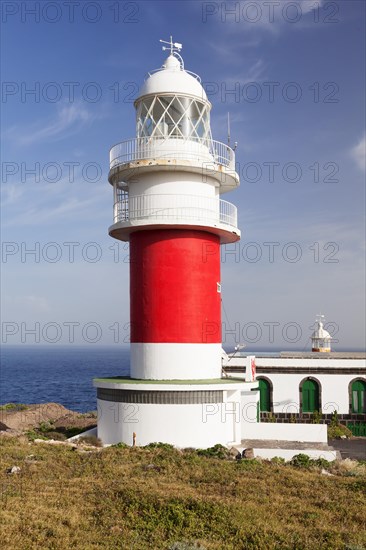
224, 352, 366, 435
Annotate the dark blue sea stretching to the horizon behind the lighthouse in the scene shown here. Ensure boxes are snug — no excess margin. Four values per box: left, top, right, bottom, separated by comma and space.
0, 344, 364, 412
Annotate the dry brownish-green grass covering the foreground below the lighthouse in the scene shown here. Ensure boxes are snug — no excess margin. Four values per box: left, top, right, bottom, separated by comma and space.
0, 438, 366, 550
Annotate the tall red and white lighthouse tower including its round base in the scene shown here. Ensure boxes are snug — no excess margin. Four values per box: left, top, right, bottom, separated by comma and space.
94, 38, 254, 447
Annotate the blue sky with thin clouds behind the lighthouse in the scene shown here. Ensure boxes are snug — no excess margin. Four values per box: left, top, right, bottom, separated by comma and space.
1, 0, 365, 350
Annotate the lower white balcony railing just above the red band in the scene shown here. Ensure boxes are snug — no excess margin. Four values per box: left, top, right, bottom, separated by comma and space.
114, 194, 238, 228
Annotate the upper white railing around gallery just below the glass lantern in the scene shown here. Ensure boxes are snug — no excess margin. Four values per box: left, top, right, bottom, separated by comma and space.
109, 136, 235, 171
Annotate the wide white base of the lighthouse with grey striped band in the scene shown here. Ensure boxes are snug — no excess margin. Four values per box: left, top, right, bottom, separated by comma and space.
94, 378, 257, 448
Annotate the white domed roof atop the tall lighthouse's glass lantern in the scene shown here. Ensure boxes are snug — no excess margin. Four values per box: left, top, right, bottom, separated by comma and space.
135, 54, 209, 103
